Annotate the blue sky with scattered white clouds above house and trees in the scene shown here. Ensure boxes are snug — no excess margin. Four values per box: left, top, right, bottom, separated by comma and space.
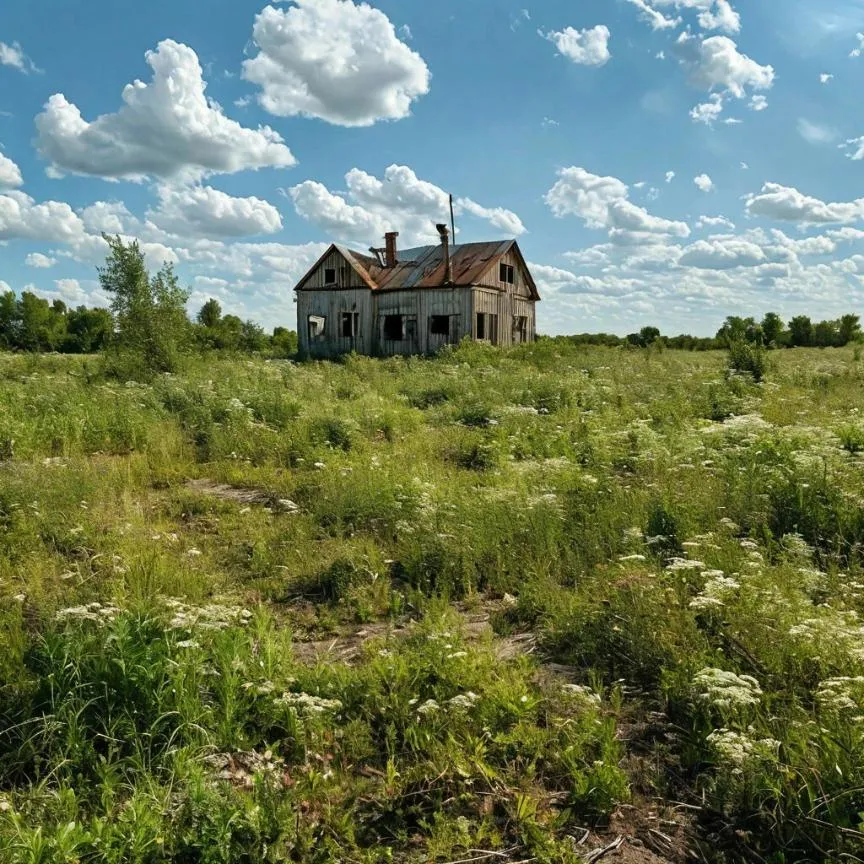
0, 0, 864, 333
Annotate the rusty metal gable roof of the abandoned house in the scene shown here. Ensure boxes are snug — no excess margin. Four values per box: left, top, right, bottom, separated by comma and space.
294, 240, 540, 300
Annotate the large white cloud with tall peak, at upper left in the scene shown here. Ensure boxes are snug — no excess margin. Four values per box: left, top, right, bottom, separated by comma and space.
36, 39, 296, 179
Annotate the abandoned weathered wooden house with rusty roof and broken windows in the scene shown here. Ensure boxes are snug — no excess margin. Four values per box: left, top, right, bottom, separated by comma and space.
295, 225, 540, 357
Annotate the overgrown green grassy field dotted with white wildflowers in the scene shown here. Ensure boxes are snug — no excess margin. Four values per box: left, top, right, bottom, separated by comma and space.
0, 342, 864, 864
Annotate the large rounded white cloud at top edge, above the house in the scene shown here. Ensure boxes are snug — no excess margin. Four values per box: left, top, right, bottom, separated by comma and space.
243, 0, 430, 126
